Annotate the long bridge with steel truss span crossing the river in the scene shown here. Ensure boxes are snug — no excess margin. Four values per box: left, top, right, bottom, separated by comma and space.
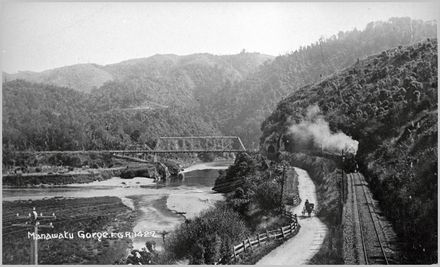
12, 136, 246, 155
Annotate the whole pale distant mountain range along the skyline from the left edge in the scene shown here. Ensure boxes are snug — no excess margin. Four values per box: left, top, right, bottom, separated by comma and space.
3, 51, 273, 106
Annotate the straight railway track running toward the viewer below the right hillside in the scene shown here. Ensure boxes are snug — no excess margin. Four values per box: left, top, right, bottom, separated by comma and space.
347, 173, 392, 264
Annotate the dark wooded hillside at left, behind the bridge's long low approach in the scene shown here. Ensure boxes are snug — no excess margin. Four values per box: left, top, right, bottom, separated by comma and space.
2, 80, 218, 153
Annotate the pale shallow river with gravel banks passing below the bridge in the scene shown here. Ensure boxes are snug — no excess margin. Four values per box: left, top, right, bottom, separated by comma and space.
2, 160, 233, 250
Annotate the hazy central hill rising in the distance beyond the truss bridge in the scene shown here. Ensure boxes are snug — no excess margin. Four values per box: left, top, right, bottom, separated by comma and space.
97, 52, 272, 107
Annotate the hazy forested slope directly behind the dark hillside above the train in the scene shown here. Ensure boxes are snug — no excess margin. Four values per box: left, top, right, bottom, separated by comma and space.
207, 18, 437, 146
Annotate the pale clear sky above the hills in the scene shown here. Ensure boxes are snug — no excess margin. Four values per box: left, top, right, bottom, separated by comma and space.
0, 2, 439, 73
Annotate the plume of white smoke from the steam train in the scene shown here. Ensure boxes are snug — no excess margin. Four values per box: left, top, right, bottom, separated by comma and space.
288, 105, 359, 154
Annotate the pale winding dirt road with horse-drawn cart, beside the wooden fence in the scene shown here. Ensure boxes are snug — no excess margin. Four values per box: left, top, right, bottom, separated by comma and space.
257, 168, 327, 265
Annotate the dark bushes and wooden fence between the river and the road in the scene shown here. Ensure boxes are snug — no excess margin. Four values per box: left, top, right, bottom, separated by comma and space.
160, 153, 299, 264
